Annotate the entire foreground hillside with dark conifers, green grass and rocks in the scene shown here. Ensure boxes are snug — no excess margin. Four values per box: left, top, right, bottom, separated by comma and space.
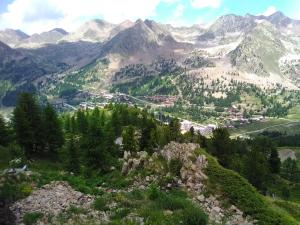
0, 93, 299, 225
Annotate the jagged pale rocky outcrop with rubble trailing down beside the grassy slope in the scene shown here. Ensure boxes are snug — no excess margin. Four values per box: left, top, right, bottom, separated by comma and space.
161, 142, 254, 225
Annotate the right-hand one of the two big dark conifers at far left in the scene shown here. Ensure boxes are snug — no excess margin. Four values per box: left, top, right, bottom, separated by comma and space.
43, 104, 64, 154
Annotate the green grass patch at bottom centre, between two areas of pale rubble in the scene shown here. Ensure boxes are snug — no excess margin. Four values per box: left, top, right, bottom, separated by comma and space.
103, 185, 208, 225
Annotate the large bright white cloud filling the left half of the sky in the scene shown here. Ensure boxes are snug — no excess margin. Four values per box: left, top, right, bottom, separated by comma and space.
0, 0, 163, 34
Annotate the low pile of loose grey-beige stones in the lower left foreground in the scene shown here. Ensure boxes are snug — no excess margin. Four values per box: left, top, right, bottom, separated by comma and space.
10, 181, 94, 224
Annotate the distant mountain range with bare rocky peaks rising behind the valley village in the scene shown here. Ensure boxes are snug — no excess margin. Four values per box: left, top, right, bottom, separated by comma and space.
0, 12, 300, 106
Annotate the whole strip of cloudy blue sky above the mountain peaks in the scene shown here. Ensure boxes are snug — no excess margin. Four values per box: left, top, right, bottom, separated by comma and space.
0, 0, 300, 34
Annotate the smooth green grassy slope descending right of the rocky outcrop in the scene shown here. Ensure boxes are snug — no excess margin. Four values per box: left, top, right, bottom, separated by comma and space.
198, 150, 299, 225
